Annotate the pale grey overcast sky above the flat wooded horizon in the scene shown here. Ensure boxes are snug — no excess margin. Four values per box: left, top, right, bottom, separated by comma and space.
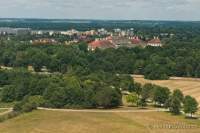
0, 0, 200, 20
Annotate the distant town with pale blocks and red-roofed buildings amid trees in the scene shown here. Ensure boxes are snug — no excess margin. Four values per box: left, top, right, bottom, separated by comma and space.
0, 27, 174, 51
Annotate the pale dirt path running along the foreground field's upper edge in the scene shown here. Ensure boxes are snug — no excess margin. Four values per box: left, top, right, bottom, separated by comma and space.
38, 107, 169, 113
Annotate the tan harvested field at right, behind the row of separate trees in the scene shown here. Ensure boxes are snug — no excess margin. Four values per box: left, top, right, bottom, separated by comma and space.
134, 75, 200, 103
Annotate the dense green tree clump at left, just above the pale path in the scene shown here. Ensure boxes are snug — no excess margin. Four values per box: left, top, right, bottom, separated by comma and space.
0, 69, 134, 108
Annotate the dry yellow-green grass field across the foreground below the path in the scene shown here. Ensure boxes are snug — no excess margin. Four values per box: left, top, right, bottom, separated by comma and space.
0, 110, 200, 133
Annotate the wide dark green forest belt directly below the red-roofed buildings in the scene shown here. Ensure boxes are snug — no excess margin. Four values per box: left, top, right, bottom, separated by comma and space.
0, 39, 200, 79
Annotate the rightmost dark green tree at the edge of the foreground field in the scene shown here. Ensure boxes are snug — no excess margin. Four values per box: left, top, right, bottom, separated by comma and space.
184, 96, 198, 117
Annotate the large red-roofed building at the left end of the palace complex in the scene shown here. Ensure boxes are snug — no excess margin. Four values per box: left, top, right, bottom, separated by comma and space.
88, 39, 116, 51
